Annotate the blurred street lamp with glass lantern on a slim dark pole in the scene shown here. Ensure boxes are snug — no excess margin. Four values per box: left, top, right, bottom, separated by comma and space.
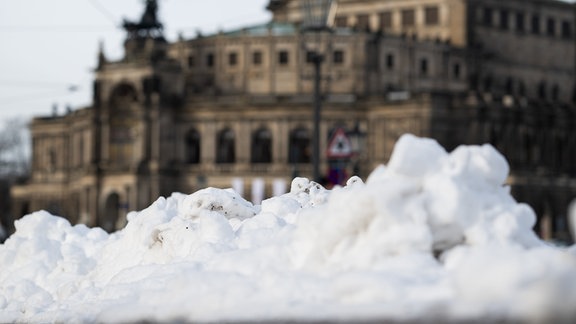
301, 0, 337, 182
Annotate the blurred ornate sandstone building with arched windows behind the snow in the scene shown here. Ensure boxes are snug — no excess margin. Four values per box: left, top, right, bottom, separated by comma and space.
12, 0, 576, 240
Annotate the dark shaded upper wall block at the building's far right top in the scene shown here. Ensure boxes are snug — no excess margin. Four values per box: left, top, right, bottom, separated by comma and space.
470, 0, 576, 102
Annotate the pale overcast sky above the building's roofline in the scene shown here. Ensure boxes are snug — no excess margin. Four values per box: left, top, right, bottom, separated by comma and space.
0, 0, 270, 121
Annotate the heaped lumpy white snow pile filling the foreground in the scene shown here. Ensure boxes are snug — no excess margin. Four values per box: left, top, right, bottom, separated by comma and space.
0, 135, 576, 322
